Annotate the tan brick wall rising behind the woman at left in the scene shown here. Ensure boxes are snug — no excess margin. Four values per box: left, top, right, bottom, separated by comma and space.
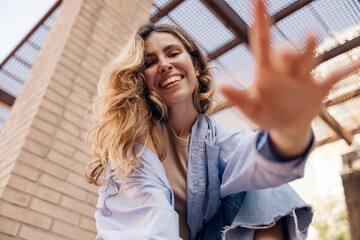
0, 0, 152, 240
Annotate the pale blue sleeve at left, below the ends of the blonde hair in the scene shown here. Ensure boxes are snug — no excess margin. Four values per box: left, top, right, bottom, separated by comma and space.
95, 149, 180, 240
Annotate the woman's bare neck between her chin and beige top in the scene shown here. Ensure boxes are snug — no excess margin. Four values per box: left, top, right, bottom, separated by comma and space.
169, 105, 198, 138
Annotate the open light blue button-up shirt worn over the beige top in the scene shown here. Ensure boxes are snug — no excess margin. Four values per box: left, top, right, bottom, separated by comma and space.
95, 114, 310, 240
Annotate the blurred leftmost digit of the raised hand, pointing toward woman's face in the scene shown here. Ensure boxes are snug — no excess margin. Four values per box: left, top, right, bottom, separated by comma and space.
220, 86, 256, 118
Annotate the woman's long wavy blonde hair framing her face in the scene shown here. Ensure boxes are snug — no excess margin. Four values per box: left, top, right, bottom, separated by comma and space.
85, 24, 214, 185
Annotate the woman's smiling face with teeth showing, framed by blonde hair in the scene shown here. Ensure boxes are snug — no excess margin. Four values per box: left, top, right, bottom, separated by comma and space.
144, 32, 197, 109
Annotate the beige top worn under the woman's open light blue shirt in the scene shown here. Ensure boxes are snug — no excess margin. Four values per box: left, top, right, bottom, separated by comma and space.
157, 124, 190, 240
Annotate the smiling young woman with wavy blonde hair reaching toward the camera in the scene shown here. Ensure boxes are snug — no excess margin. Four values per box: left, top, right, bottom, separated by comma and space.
86, 0, 355, 239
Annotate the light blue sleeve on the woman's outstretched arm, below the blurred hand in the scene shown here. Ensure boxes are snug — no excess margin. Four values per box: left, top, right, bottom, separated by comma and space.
216, 124, 314, 197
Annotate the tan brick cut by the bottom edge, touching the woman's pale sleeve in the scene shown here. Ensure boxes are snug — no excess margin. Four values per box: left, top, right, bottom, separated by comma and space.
52, 220, 96, 240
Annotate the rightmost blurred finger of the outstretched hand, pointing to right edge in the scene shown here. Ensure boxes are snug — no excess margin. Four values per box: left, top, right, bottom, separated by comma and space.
319, 61, 360, 93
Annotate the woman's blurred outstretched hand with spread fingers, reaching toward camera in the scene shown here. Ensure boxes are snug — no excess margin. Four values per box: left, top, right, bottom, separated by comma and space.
220, 0, 359, 154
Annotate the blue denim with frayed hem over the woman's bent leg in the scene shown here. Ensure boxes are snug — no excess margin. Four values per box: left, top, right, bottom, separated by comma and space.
196, 184, 314, 240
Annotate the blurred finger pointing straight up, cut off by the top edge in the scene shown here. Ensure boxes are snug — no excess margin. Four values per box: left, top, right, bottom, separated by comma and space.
249, 0, 271, 65
